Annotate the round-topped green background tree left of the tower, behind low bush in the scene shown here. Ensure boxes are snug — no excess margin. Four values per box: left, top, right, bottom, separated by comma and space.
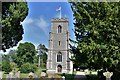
15, 42, 36, 67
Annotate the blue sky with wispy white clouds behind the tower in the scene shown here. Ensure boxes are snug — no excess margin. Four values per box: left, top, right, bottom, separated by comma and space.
0, 2, 75, 53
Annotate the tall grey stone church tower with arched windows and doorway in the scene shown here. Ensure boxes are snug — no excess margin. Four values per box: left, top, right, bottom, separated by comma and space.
47, 18, 73, 74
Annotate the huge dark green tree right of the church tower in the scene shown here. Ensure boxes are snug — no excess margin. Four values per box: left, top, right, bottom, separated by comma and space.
71, 2, 120, 71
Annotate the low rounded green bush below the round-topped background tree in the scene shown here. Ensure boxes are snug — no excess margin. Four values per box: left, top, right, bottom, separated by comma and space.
20, 63, 37, 73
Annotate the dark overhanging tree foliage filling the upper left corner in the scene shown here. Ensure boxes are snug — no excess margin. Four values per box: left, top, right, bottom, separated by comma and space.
2, 2, 28, 51
